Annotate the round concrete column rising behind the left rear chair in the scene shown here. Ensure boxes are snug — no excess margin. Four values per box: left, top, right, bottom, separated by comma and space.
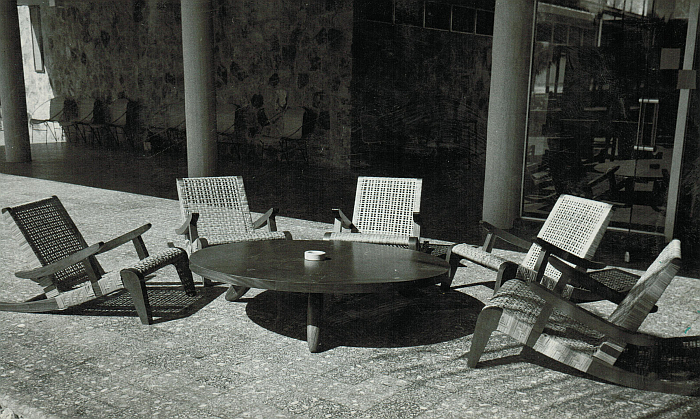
180, 0, 217, 177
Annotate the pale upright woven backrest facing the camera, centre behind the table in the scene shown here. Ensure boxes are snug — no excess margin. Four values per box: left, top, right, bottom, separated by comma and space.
352, 176, 423, 237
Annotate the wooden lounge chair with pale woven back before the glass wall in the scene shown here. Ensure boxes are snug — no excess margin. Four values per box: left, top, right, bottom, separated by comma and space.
448, 195, 638, 302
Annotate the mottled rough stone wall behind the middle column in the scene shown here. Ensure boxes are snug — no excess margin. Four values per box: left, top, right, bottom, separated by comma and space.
35, 0, 352, 166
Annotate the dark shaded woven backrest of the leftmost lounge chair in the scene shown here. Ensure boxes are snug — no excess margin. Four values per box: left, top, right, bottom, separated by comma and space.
3, 196, 101, 292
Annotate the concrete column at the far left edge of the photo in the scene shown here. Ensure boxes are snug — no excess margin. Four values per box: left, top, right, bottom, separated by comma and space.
0, 0, 32, 163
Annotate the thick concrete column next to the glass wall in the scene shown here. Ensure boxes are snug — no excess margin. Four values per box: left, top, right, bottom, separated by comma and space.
482, 0, 535, 228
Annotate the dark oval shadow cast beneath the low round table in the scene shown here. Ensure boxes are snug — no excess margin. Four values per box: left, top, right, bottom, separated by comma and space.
246, 286, 483, 351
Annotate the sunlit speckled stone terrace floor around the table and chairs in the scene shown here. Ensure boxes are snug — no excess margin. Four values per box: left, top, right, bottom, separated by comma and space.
0, 144, 700, 419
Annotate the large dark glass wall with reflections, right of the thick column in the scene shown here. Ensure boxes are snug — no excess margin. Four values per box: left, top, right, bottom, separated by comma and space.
522, 0, 691, 234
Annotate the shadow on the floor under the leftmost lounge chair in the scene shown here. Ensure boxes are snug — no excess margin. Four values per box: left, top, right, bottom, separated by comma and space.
49, 282, 226, 324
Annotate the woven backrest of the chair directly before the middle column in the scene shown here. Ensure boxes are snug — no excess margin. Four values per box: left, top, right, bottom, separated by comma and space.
177, 176, 254, 243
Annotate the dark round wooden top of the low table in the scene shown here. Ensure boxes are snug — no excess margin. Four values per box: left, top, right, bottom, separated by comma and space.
190, 240, 449, 293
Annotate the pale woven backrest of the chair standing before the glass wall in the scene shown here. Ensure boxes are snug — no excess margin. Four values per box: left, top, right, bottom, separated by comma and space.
519, 195, 613, 288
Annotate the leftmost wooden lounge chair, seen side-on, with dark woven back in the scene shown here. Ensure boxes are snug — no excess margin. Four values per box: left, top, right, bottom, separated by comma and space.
0, 195, 196, 324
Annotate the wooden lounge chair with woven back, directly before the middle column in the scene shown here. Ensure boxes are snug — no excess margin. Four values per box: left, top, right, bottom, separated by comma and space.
175, 176, 292, 301
